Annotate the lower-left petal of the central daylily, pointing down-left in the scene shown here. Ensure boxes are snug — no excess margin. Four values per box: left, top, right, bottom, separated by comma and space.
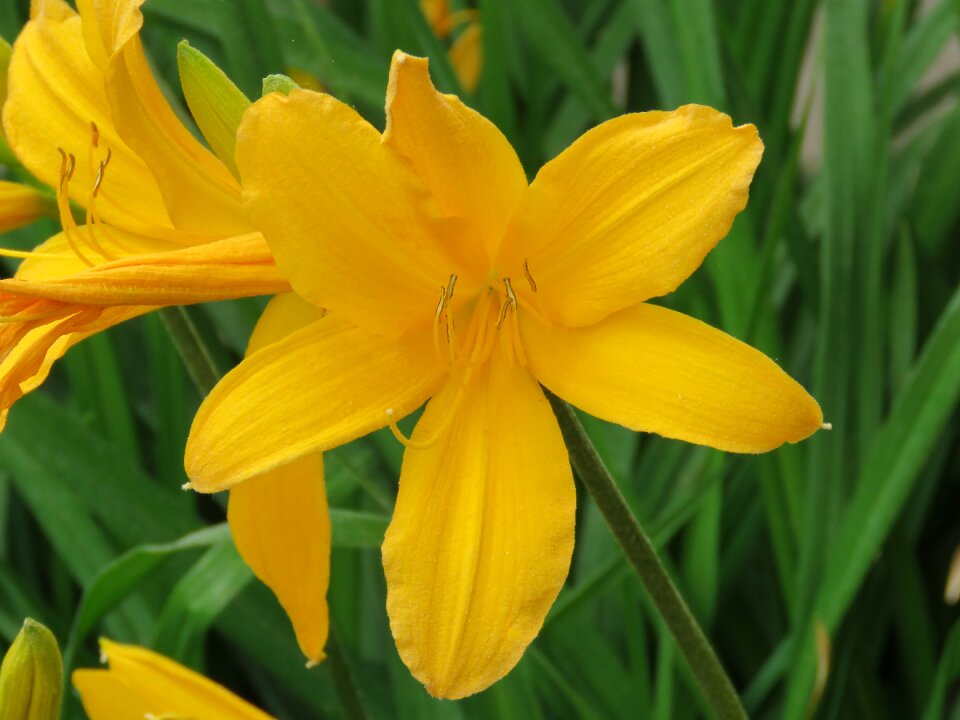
186, 314, 443, 492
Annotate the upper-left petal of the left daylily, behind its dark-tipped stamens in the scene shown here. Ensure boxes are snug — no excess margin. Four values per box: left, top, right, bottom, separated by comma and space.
3, 0, 174, 235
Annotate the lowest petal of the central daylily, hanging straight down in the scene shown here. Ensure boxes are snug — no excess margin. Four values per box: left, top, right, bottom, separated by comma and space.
383, 351, 576, 698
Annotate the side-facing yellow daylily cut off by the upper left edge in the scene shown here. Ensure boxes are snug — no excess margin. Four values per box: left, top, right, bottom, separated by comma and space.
0, 0, 288, 426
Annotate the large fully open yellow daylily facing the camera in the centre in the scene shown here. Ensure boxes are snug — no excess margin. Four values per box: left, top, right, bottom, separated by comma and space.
186, 52, 822, 698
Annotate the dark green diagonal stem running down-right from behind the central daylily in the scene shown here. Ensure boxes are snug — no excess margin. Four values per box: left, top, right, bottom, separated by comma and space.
547, 393, 747, 720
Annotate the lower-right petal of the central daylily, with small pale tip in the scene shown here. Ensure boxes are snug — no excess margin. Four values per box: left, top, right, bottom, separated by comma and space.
522, 304, 823, 453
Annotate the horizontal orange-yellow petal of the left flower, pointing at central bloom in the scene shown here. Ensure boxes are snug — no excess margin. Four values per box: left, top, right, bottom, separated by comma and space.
0, 233, 290, 312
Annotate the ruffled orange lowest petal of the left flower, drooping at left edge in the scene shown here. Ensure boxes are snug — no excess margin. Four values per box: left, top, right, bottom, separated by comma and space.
0, 302, 154, 430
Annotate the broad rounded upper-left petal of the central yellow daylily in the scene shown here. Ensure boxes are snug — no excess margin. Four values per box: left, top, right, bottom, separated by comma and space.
237, 90, 458, 335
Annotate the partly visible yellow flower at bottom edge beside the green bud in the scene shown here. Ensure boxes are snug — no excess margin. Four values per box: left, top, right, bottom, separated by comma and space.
73, 640, 271, 720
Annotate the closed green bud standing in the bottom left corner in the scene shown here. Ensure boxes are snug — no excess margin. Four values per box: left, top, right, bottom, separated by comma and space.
0, 618, 63, 720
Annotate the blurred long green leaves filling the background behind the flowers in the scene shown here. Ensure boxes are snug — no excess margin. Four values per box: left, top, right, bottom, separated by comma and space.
0, 0, 960, 720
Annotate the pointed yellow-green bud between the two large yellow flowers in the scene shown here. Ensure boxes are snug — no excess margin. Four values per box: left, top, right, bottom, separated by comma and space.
177, 40, 250, 177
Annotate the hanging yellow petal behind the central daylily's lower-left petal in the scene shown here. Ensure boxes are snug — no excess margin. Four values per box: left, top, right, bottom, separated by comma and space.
227, 293, 330, 663
